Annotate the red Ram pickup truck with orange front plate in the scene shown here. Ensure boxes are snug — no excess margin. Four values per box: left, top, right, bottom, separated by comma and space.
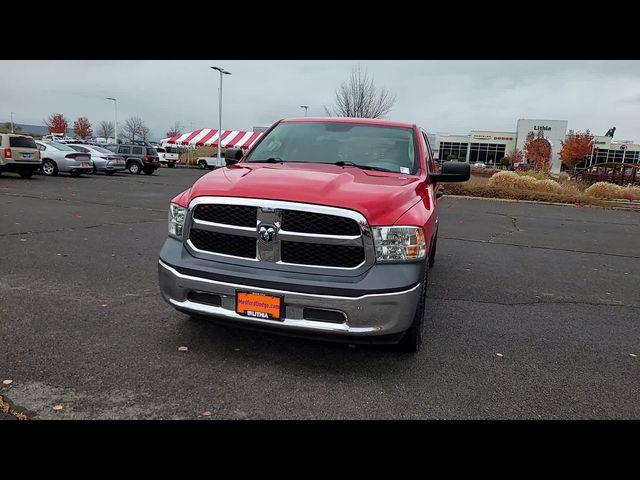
158, 117, 470, 352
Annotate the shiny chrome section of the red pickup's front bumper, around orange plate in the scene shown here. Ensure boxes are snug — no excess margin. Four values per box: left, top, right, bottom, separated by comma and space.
158, 260, 421, 337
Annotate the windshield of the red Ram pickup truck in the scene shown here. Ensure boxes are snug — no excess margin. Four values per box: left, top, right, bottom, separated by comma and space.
245, 122, 420, 174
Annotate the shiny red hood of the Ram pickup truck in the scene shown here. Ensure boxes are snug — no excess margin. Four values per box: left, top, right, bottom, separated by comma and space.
182, 163, 425, 225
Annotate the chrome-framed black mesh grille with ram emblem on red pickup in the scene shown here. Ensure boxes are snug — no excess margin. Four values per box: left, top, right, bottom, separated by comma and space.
188, 197, 374, 271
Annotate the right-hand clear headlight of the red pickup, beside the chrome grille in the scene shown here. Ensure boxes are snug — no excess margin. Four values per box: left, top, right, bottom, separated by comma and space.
371, 227, 427, 262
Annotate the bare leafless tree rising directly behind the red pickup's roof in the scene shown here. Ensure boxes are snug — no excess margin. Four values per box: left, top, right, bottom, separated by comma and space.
325, 65, 396, 118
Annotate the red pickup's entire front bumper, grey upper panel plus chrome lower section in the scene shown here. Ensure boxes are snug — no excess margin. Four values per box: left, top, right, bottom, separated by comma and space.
158, 239, 424, 343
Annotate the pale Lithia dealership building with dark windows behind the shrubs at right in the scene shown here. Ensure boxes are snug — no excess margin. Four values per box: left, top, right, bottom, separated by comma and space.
429, 119, 640, 173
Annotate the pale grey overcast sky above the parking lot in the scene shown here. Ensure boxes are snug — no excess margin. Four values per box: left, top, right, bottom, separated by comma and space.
0, 60, 640, 142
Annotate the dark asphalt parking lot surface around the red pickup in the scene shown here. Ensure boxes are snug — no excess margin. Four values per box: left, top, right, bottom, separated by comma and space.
0, 168, 640, 419
